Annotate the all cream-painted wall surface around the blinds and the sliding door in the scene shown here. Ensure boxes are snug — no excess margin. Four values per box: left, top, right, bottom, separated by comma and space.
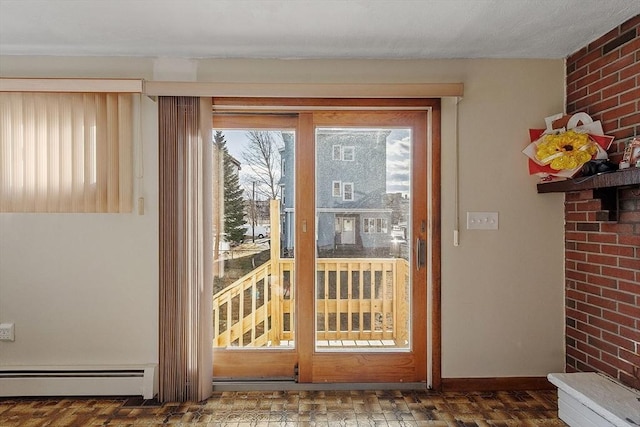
0, 57, 564, 378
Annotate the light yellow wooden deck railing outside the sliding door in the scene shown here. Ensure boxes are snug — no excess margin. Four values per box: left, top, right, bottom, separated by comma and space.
213, 258, 408, 347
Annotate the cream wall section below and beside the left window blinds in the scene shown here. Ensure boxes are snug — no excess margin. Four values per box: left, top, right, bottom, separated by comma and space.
0, 83, 158, 367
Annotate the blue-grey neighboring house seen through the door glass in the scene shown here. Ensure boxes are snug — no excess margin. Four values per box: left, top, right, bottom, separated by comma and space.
281, 129, 392, 255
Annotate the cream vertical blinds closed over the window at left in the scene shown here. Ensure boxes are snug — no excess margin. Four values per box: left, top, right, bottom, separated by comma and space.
0, 92, 134, 212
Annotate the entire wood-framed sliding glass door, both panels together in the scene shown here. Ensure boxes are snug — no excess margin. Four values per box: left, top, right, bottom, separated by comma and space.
213, 103, 429, 383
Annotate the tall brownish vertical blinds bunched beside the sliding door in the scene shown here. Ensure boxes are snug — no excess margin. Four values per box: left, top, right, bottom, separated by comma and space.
158, 97, 213, 402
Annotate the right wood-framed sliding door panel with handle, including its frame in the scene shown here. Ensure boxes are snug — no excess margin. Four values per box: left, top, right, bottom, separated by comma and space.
298, 111, 428, 383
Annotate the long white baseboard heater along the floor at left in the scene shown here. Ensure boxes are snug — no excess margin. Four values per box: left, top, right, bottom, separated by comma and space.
0, 365, 157, 399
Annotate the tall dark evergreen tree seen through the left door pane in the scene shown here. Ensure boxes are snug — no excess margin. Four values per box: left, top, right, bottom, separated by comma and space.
213, 131, 246, 243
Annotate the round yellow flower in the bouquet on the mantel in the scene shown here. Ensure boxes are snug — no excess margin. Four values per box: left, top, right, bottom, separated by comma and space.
536, 130, 598, 170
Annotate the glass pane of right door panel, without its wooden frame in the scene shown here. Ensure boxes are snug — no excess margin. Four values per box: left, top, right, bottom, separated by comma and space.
315, 127, 413, 352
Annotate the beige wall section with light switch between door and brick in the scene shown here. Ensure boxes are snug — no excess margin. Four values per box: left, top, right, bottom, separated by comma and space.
442, 61, 564, 377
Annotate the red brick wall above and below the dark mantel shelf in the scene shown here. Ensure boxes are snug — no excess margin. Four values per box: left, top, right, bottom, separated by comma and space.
565, 15, 640, 388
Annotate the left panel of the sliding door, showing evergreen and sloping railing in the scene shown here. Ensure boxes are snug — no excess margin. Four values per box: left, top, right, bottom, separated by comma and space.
213, 115, 297, 379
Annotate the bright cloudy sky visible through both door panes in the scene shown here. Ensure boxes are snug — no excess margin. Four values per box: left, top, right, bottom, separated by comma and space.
218, 129, 411, 199
